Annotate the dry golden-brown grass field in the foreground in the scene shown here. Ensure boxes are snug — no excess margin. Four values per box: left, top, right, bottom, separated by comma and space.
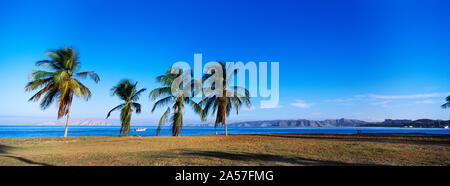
0, 134, 450, 166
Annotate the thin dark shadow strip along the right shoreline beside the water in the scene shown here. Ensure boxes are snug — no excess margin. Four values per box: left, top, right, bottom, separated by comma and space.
248, 134, 450, 145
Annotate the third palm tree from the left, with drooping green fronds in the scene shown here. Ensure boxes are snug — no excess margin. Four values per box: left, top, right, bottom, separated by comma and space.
149, 69, 206, 136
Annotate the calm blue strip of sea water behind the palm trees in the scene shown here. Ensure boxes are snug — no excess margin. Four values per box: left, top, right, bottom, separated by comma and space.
0, 125, 450, 138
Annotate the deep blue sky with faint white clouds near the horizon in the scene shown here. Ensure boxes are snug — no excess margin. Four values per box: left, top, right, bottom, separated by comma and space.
0, 0, 450, 124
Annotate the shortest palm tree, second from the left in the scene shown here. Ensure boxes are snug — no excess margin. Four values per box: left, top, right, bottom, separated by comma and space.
106, 79, 147, 136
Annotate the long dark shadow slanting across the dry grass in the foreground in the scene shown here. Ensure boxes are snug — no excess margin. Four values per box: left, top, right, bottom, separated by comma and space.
183, 151, 382, 166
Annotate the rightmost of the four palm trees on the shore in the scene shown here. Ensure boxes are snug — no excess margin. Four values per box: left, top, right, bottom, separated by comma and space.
200, 62, 251, 136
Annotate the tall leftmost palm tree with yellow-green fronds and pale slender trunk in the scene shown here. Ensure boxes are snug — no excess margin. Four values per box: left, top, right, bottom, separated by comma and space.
25, 48, 100, 137
